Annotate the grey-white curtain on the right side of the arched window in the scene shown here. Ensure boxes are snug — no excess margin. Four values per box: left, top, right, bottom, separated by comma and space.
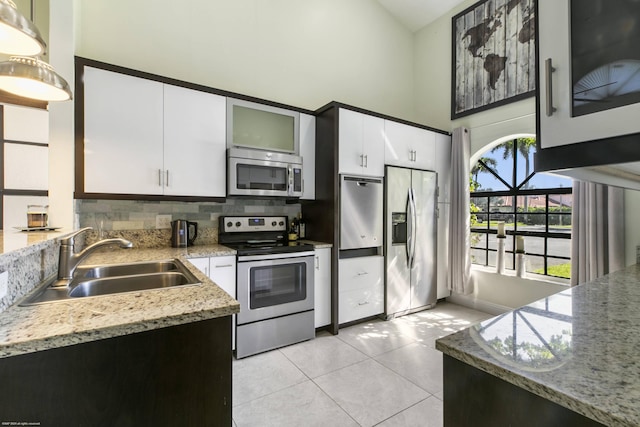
571, 181, 625, 286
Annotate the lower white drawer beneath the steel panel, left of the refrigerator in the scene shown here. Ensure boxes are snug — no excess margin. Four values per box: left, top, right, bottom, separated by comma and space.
338, 284, 384, 323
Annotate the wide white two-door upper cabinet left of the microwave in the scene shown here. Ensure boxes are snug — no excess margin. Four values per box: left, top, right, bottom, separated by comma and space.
84, 67, 226, 197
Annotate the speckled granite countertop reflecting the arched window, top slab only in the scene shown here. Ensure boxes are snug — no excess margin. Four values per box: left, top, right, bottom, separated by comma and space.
436, 266, 640, 426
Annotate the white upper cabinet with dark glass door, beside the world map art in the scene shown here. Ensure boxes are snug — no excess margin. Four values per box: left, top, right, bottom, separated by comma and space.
536, 0, 640, 178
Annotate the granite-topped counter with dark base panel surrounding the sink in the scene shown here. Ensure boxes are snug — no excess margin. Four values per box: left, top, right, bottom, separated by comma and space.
0, 234, 239, 426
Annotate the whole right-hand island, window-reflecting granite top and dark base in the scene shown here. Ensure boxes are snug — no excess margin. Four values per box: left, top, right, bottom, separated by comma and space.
436, 266, 640, 427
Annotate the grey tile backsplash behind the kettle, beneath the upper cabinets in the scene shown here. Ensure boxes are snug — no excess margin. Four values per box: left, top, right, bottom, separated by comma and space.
75, 199, 300, 244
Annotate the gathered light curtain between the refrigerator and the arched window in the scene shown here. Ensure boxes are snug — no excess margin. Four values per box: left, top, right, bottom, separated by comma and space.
448, 128, 473, 294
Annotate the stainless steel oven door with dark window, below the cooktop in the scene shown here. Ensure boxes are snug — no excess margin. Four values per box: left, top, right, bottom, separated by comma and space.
237, 252, 314, 325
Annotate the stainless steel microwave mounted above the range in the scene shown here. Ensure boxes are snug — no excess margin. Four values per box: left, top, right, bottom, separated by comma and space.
227, 157, 302, 197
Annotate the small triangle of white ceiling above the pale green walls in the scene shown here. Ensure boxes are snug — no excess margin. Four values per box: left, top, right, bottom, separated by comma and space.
378, 0, 465, 32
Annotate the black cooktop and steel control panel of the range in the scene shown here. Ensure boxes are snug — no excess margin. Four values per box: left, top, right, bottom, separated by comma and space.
218, 216, 314, 255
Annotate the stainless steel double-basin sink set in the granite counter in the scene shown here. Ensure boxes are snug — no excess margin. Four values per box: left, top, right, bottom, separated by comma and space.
20, 259, 200, 306
